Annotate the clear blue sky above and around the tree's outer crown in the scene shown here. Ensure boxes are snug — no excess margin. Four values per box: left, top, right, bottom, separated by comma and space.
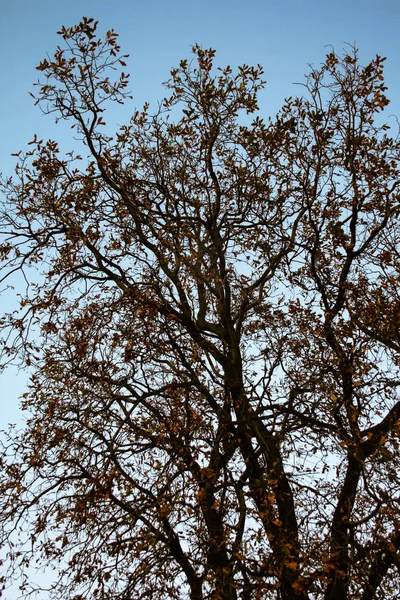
0, 0, 400, 600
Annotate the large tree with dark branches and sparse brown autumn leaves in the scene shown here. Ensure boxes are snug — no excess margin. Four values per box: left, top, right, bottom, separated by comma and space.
0, 18, 400, 600
